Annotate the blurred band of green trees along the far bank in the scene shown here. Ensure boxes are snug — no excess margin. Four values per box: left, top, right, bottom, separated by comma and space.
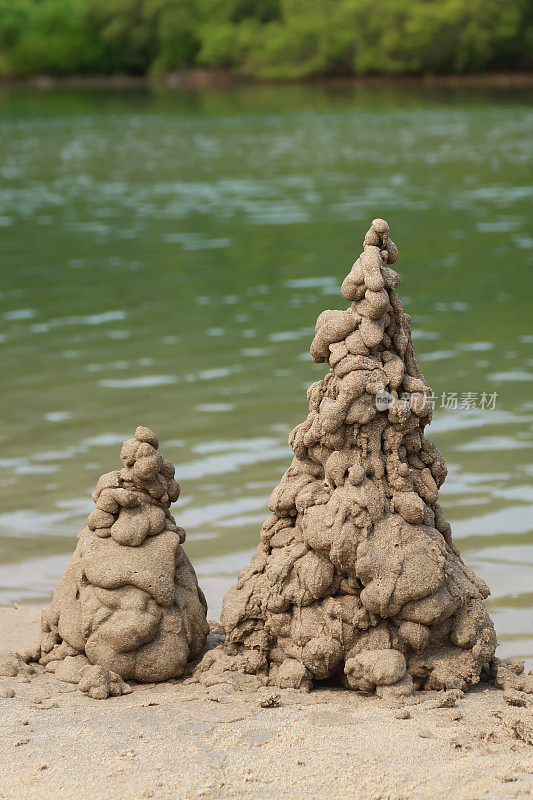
0, 0, 533, 79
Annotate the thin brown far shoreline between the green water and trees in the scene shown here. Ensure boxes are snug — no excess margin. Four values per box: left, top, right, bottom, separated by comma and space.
0, 69, 533, 90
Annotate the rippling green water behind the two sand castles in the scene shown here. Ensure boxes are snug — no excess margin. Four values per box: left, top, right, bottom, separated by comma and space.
0, 86, 533, 657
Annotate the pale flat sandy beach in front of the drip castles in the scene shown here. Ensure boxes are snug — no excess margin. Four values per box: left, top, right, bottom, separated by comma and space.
0, 608, 533, 800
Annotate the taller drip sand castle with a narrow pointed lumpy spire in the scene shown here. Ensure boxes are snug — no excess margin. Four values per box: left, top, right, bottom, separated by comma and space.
199, 219, 496, 696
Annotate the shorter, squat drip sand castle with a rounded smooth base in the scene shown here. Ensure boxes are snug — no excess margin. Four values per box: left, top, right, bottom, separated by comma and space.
39, 427, 209, 697
